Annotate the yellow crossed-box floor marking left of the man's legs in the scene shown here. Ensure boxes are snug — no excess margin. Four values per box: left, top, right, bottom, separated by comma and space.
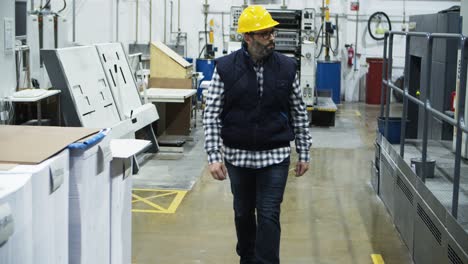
132, 189, 187, 214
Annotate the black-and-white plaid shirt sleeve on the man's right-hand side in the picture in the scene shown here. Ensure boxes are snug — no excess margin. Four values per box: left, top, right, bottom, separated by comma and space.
289, 74, 312, 162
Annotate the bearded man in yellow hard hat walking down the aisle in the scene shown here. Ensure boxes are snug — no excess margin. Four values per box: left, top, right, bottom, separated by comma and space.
203, 5, 311, 264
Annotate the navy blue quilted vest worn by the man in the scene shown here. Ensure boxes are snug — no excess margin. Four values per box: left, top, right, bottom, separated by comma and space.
216, 49, 297, 150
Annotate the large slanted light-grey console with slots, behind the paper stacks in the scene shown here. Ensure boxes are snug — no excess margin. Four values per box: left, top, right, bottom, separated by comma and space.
41, 43, 159, 152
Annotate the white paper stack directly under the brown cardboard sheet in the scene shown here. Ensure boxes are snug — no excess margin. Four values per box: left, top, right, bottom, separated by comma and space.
2, 150, 69, 264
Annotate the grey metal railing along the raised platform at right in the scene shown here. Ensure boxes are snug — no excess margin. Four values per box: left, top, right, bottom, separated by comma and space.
380, 31, 468, 218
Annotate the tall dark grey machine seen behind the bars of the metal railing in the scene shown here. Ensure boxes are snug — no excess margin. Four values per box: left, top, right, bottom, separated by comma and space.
406, 12, 460, 140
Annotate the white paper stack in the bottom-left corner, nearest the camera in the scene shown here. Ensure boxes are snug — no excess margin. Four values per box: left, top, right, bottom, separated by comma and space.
0, 174, 35, 264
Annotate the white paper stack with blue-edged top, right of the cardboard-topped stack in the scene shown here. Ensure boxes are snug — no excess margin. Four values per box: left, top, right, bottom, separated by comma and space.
68, 137, 111, 264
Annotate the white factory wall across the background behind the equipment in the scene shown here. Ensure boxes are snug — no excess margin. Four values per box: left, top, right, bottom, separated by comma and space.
45, 0, 460, 101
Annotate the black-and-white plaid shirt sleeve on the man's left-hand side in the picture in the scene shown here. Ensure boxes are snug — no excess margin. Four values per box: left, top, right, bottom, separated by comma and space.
203, 69, 224, 164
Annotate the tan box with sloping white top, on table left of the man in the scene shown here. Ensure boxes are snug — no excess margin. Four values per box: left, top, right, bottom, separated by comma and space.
150, 41, 193, 79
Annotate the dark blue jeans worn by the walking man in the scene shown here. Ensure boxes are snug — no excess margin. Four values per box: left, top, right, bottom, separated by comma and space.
226, 157, 290, 264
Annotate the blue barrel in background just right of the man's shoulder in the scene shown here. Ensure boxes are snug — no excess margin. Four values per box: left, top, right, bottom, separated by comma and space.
315, 61, 341, 104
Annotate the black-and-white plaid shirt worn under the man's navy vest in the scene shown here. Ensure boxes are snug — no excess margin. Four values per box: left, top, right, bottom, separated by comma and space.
203, 60, 312, 168
